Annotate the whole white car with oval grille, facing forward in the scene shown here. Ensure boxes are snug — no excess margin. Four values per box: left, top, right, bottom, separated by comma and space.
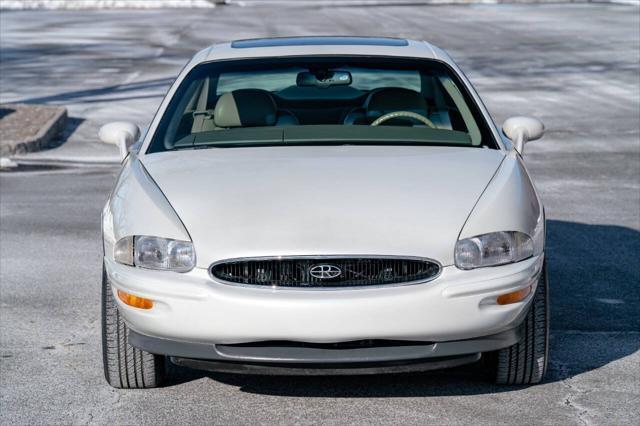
100, 37, 549, 388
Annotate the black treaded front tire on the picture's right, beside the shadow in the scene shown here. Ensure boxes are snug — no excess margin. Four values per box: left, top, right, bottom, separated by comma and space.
489, 262, 549, 385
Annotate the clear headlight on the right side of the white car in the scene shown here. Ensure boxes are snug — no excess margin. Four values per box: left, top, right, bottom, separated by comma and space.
454, 231, 534, 269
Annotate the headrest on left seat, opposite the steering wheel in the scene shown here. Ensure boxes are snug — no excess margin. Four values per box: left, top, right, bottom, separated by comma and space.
213, 89, 277, 127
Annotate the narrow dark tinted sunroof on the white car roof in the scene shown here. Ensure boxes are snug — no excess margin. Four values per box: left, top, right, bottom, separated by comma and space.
231, 36, 409, 49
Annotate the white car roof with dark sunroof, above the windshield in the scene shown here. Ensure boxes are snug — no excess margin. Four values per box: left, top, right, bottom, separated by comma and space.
192, 36, 451, 65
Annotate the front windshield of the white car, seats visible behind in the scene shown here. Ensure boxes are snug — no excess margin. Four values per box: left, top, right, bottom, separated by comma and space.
148, 57, 497, 152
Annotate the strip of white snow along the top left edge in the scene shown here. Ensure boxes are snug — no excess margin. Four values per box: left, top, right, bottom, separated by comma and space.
0, 0, 214, 10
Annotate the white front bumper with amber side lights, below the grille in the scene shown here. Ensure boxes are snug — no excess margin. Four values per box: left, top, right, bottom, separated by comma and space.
105, 255, 543, 346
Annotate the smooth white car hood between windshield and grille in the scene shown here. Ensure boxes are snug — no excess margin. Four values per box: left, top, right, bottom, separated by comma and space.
141, 146, 504, 267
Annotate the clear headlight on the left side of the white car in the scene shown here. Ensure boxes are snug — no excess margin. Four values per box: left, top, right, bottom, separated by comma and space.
113, 235, 196, 272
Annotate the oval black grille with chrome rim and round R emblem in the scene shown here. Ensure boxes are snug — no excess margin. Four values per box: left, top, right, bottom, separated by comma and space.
211, 257, 440, 288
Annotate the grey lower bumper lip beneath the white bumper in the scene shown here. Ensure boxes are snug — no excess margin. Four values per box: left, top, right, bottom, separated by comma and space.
128, 325, 523, 375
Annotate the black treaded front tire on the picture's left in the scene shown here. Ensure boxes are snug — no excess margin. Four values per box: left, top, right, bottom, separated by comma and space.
102, 267, 165, 389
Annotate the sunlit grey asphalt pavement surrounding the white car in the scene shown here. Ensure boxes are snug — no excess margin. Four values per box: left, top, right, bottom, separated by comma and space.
0, 4, 640, 425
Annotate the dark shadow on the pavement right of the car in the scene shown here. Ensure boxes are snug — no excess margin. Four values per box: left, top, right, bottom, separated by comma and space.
546, 220, 640, 331
